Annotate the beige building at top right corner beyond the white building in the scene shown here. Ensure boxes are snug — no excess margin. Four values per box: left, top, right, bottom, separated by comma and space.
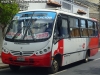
74, 0, 100, 22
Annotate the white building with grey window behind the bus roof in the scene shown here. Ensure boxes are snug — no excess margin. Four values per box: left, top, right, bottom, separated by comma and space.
28, 0, 89, 17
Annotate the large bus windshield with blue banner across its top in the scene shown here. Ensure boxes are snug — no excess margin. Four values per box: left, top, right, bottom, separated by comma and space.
5, 11, 56, 41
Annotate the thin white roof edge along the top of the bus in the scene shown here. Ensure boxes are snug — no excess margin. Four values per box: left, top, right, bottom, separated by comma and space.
18, 8, 97, 21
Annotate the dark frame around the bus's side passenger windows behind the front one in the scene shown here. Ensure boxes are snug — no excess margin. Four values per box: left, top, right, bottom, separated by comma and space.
54, 13, 98, 39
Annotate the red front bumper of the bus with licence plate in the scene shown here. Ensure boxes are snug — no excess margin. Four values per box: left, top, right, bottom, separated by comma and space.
1, 52, 51, 67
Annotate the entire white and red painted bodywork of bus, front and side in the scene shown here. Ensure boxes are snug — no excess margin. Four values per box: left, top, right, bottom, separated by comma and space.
1, 10, 99, 70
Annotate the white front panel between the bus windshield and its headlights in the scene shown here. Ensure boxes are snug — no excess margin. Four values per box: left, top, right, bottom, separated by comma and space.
3, 40, 50, 51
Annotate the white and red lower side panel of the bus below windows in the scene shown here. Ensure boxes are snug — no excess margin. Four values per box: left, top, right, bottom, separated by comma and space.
52, 38, 98, 66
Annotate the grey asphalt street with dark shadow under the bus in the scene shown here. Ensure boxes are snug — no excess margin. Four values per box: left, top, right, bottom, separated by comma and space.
0, 52, 100, 75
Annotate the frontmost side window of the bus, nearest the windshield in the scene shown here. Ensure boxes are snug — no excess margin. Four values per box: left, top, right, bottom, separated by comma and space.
54, 15, 69, 38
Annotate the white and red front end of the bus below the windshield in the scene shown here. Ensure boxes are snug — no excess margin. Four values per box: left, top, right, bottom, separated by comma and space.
1, 40, 52, 67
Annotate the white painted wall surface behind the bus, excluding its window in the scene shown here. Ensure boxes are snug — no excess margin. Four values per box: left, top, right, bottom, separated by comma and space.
28, 0, 89, 17
